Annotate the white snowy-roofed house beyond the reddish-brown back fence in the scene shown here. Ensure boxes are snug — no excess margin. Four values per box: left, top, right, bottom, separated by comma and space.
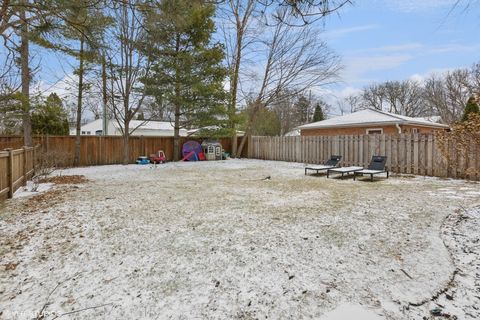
70, 119, 187, 137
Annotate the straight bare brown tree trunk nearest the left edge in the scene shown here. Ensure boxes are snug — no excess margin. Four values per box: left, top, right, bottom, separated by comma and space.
20, 4, 33, 147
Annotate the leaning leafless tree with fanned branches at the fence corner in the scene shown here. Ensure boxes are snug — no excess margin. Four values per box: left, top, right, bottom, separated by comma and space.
237, 10, 340, 154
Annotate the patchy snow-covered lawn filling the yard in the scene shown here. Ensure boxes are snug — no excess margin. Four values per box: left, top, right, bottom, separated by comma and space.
0, 160, 480, 319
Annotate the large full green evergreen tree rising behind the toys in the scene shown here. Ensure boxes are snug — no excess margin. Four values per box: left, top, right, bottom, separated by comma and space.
145, 0, 228, 160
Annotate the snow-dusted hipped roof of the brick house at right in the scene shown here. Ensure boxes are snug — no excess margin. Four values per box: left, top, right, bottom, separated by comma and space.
298, 109, 448, 130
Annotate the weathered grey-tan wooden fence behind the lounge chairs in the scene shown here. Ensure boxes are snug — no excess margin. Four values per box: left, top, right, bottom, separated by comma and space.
248, 134, 480, 180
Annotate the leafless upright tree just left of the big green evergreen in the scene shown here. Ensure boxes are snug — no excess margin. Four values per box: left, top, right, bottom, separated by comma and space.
106, 0, 151, 164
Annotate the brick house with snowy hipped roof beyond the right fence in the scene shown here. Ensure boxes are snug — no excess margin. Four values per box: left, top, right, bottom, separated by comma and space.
298, 109, 449, 136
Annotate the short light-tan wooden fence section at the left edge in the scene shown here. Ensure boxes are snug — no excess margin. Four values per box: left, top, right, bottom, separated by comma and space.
0, 147, 35, 200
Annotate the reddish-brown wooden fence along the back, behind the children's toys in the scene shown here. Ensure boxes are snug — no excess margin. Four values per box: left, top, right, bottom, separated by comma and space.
0, 136, 247, 167
